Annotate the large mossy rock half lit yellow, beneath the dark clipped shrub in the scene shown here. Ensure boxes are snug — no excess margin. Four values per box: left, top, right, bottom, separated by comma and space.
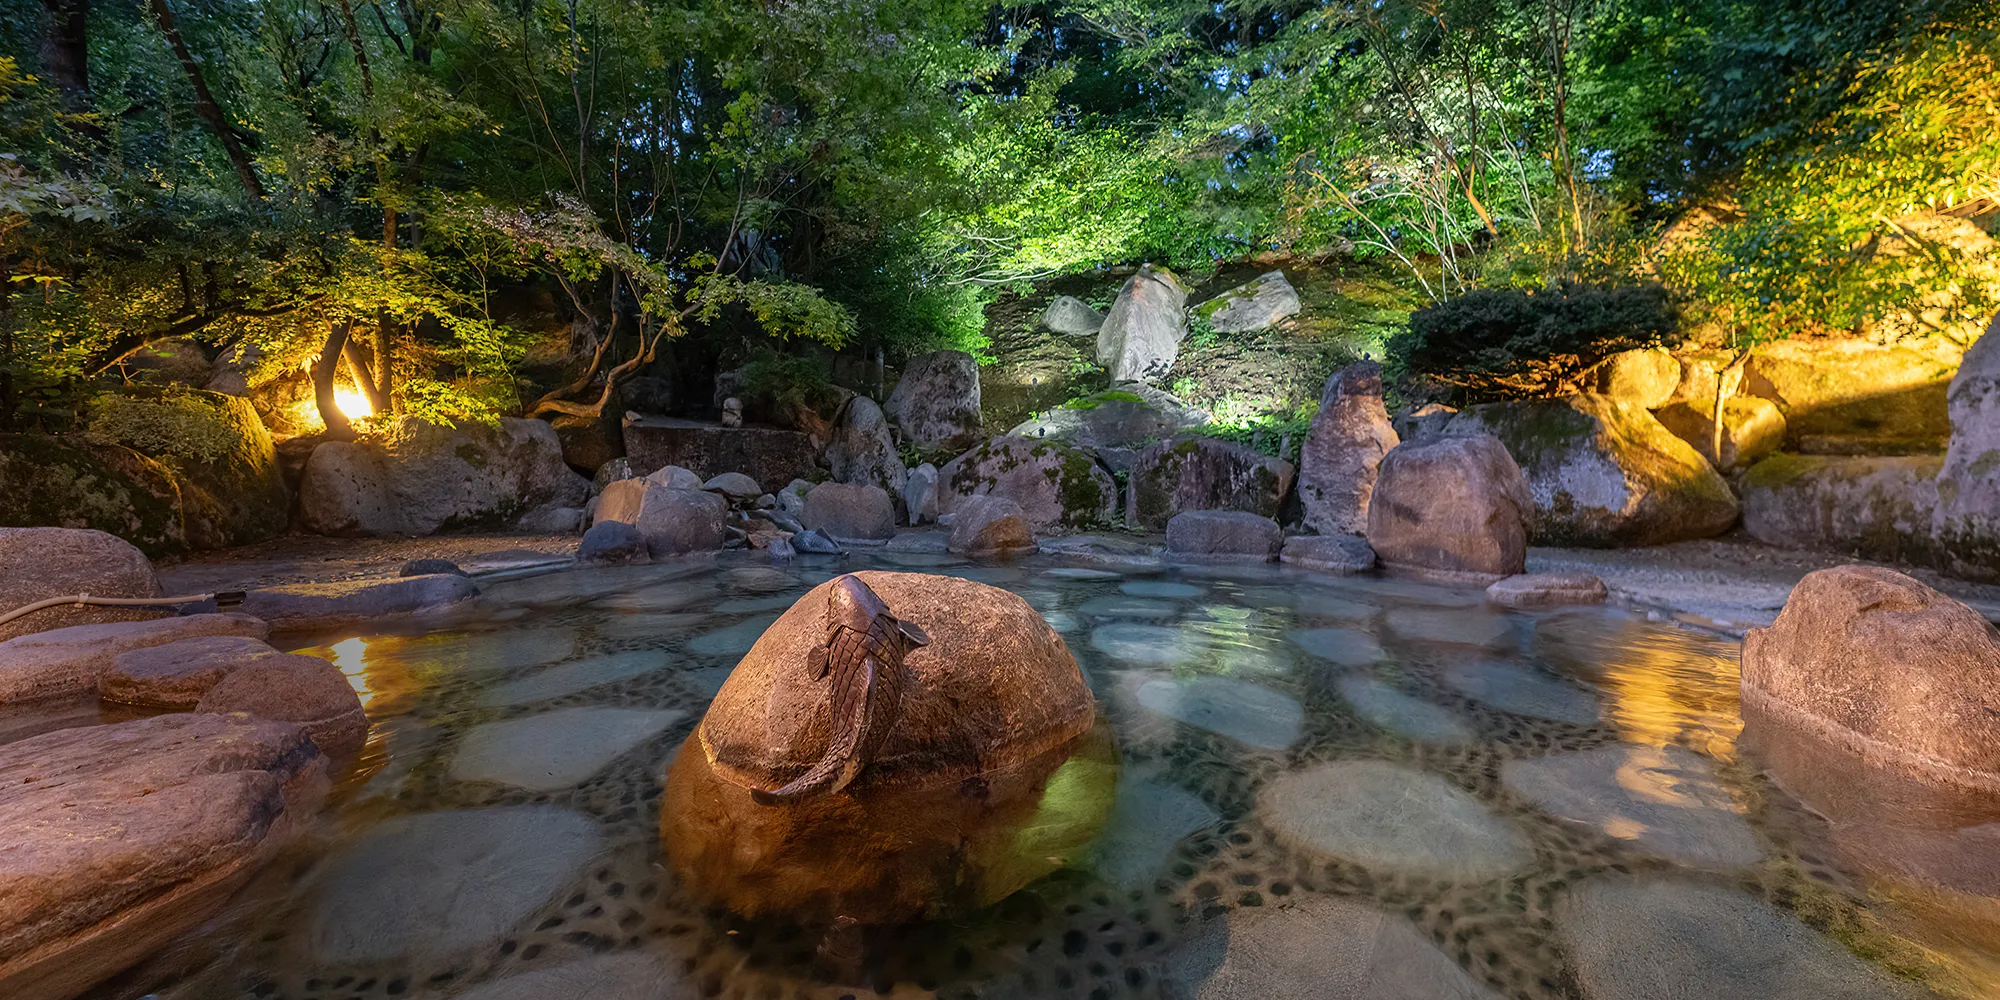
1446, 392, 1738, 548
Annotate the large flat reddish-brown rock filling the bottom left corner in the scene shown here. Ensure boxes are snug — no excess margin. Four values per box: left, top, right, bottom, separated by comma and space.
0, 720, 328, 998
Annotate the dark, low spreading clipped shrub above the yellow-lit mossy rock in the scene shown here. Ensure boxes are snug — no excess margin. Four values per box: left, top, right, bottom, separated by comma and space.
1388, 284, 1680, 402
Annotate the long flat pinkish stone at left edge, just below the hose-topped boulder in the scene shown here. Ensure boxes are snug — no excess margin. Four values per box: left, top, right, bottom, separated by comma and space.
0, 614, 270, 704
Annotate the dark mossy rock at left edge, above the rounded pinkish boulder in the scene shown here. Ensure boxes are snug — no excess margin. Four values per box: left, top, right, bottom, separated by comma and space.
0, 434, 188, 556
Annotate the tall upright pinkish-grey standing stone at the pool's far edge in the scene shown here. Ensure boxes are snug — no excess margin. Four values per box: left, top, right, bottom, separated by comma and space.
1298, 362, 1398, 534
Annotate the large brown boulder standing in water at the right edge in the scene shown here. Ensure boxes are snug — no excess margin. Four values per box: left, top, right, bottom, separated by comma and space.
1742, 566, 2000, 794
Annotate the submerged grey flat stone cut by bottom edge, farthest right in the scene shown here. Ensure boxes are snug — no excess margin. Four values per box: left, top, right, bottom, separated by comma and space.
1556, 876, 1930, 1000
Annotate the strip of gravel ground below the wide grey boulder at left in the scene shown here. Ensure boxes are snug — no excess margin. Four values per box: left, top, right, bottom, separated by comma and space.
160, 534, 578, 594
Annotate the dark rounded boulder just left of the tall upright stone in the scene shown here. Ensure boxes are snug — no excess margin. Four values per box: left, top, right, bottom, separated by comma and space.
1126, 436, 1292, 530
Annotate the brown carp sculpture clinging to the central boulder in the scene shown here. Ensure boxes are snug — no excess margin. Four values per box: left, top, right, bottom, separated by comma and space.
752, 574, 930, 804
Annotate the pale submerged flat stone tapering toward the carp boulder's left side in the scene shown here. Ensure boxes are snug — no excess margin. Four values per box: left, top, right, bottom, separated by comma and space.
450, 708, 686, 792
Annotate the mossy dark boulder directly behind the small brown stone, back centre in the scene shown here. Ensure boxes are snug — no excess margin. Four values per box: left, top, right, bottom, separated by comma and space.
938, 436, 1118, 532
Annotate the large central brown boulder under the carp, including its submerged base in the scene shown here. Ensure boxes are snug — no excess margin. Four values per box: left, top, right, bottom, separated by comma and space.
660, 572, 1114, 924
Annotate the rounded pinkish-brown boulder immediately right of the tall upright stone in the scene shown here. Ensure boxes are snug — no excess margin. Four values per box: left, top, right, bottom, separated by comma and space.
1368, 436, 1534, 586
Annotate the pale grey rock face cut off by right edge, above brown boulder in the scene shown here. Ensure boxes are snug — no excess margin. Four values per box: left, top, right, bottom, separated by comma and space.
1934, 318, 2000, 578
